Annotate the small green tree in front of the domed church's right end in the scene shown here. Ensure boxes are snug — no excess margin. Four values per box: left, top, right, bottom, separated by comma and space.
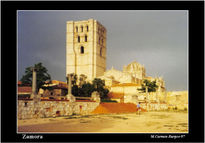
139, 79, 158, 92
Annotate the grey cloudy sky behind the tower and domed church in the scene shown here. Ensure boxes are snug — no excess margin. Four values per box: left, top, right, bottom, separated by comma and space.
17, 10, 188, 91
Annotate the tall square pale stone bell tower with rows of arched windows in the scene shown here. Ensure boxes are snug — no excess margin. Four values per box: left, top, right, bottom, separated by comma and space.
66, 19, 106, 80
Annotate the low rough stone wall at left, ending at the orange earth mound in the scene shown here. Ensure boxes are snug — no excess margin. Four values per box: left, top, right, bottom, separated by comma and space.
18, 100, 99, 119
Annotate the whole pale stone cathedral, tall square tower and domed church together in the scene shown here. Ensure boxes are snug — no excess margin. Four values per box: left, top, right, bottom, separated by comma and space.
66, 19, 165, 103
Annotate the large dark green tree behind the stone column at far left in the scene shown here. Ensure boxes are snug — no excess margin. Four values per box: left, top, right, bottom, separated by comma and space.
20, 63, 51, 91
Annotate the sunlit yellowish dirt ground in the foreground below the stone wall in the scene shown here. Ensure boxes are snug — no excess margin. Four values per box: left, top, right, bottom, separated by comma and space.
17, 112, 188, 133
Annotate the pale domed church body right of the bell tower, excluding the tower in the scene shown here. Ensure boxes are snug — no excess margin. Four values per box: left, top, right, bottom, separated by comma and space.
99, 61, 166, 104
